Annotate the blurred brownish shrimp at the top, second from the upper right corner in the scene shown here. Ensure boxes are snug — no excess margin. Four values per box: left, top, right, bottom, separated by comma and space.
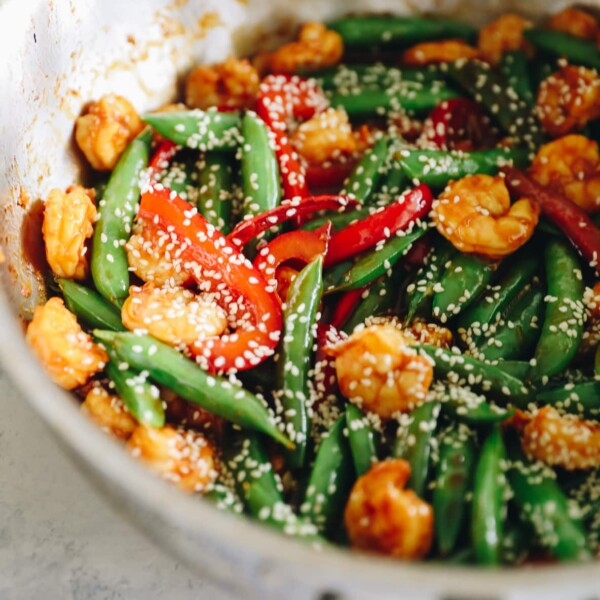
477, 13, 532, 65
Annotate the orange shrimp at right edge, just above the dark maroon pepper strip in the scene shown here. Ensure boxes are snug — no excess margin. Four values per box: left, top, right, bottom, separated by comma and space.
529, 134, 600, 213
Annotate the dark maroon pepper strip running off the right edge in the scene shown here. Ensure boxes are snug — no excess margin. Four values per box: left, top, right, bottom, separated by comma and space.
502, 167, 600, 272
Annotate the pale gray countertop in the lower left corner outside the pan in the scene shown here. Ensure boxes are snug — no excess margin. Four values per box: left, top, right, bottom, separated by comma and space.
0, 372, 231, 600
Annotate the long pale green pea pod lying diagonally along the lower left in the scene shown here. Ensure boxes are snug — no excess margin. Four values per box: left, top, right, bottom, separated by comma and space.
94, 330, 293, 447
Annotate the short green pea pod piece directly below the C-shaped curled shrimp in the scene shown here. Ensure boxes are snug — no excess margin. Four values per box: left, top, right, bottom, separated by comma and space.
433, 252, 498, 323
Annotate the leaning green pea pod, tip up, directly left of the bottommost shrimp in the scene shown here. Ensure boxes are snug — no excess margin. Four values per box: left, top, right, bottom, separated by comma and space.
300, 414, 355, 537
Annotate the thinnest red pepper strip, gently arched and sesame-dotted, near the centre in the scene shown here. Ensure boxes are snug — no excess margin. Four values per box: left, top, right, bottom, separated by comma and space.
227, 194, 357, 248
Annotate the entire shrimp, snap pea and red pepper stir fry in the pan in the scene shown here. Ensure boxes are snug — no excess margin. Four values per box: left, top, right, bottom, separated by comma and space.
27, 9, 600, 565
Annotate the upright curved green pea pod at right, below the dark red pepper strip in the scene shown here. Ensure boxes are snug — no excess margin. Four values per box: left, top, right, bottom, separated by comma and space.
529, 238, 585, 381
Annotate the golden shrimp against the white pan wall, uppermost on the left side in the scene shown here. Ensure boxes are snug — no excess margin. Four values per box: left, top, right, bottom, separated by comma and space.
75, 94, 144, 171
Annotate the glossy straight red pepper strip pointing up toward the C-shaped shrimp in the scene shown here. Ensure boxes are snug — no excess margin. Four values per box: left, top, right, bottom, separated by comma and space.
325, 184, 433, 267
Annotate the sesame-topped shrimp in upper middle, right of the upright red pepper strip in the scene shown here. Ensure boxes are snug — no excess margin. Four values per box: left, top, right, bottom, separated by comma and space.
290, 108, 356, 163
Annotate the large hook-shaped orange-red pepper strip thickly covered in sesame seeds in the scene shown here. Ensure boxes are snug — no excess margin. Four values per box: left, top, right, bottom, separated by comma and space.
138, 186, 282, 372
